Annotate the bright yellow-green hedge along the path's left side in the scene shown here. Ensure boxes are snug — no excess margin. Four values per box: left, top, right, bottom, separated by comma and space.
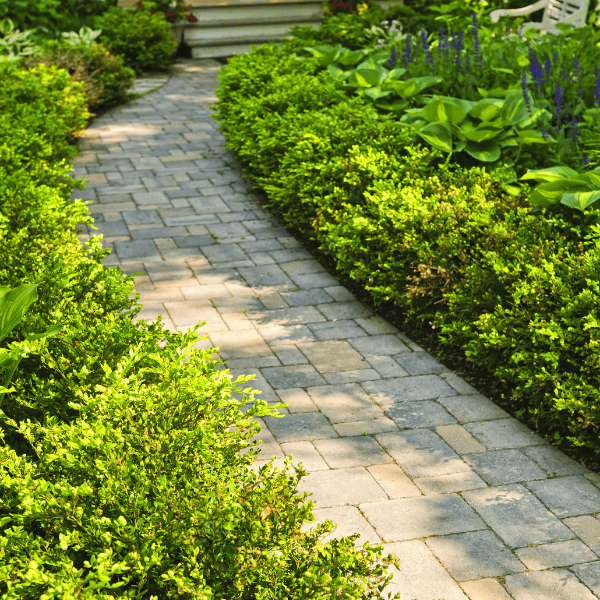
0, 54, 400, 600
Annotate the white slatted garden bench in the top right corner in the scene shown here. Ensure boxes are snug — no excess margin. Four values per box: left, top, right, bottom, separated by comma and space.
489, 0, 590, 37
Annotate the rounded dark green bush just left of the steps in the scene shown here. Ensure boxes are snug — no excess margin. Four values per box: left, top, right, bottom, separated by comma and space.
94, 7, 177, 75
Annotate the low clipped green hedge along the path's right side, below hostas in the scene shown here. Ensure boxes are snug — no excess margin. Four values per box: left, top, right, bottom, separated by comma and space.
213, 40, 600, 455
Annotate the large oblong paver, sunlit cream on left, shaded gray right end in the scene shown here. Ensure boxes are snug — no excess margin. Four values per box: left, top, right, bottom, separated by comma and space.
359, 494, 486, 542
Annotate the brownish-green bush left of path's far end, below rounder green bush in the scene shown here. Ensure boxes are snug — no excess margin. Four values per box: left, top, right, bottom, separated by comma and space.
20, 40, 135, 117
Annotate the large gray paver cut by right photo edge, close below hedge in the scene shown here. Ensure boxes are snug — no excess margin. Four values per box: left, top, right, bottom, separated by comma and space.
527, 475, 600, 519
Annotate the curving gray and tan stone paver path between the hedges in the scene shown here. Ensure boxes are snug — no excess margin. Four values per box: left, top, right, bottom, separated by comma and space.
68, 60, 600, 600
